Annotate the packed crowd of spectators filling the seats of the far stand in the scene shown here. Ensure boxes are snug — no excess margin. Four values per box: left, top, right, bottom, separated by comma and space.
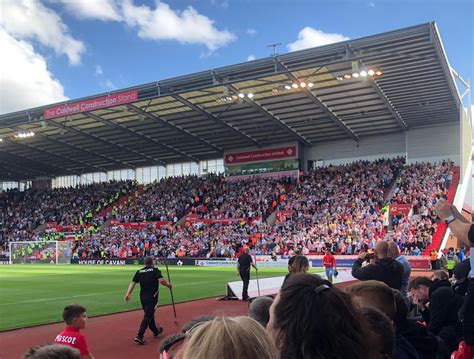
0, 158, 452, 257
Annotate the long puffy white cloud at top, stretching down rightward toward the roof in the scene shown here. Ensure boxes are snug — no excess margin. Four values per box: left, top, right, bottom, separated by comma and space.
122, 0, 235, 51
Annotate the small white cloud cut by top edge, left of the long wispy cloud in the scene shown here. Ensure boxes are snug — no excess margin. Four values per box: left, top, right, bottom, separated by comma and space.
57, 0, 121, 21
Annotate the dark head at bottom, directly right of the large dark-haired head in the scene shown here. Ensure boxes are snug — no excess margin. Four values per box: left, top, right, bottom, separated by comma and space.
361, 307, 395, 359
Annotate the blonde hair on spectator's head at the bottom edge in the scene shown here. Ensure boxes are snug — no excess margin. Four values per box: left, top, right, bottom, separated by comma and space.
181, 317, 280, 359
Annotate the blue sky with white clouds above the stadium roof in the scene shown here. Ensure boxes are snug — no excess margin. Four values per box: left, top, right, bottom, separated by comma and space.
0, 0, 474, 113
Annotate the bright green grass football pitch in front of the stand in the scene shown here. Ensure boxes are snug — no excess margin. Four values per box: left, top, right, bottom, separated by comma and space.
0, 264, 318, 331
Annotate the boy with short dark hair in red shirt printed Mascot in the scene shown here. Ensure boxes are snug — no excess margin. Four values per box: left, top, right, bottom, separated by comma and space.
54, 304, 94, 359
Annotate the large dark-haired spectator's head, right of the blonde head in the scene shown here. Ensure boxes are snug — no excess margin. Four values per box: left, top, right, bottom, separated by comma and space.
267, 273, 371, 358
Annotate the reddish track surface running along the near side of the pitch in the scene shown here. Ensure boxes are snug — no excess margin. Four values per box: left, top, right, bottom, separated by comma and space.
0, 298, 248, 359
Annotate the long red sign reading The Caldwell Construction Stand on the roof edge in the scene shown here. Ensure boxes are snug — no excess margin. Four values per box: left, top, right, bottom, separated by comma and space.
43, 90, 138, 120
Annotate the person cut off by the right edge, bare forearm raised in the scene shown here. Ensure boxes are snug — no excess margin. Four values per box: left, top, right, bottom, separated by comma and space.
435, 199, 474, 355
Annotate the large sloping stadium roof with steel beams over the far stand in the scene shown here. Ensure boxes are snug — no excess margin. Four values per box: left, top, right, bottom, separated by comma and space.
0, 23, 459, 180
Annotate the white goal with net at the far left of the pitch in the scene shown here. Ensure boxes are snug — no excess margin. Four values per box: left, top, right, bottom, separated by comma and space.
9, 241, 72, 264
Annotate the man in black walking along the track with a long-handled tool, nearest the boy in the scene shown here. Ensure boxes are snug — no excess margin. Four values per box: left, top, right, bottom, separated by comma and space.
125, 257, 172, 345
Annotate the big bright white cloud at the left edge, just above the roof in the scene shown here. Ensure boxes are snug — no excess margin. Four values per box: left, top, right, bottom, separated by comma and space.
0, 29, 68, 113
